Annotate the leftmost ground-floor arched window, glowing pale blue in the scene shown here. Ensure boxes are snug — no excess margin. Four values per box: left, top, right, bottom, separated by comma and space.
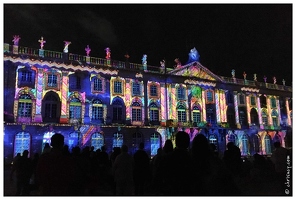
14, 131, 31, 156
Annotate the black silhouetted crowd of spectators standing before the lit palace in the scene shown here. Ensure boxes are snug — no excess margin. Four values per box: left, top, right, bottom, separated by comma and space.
10, 131, 290, 196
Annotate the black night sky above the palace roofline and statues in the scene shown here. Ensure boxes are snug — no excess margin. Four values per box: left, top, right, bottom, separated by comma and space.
4, 4, 292, 85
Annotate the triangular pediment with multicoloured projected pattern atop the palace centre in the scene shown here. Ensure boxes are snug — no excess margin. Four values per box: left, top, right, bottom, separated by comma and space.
169, 61, 222, 81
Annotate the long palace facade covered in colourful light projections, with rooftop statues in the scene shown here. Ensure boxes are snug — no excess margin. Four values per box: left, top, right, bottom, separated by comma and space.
3, 35, 292, 164
